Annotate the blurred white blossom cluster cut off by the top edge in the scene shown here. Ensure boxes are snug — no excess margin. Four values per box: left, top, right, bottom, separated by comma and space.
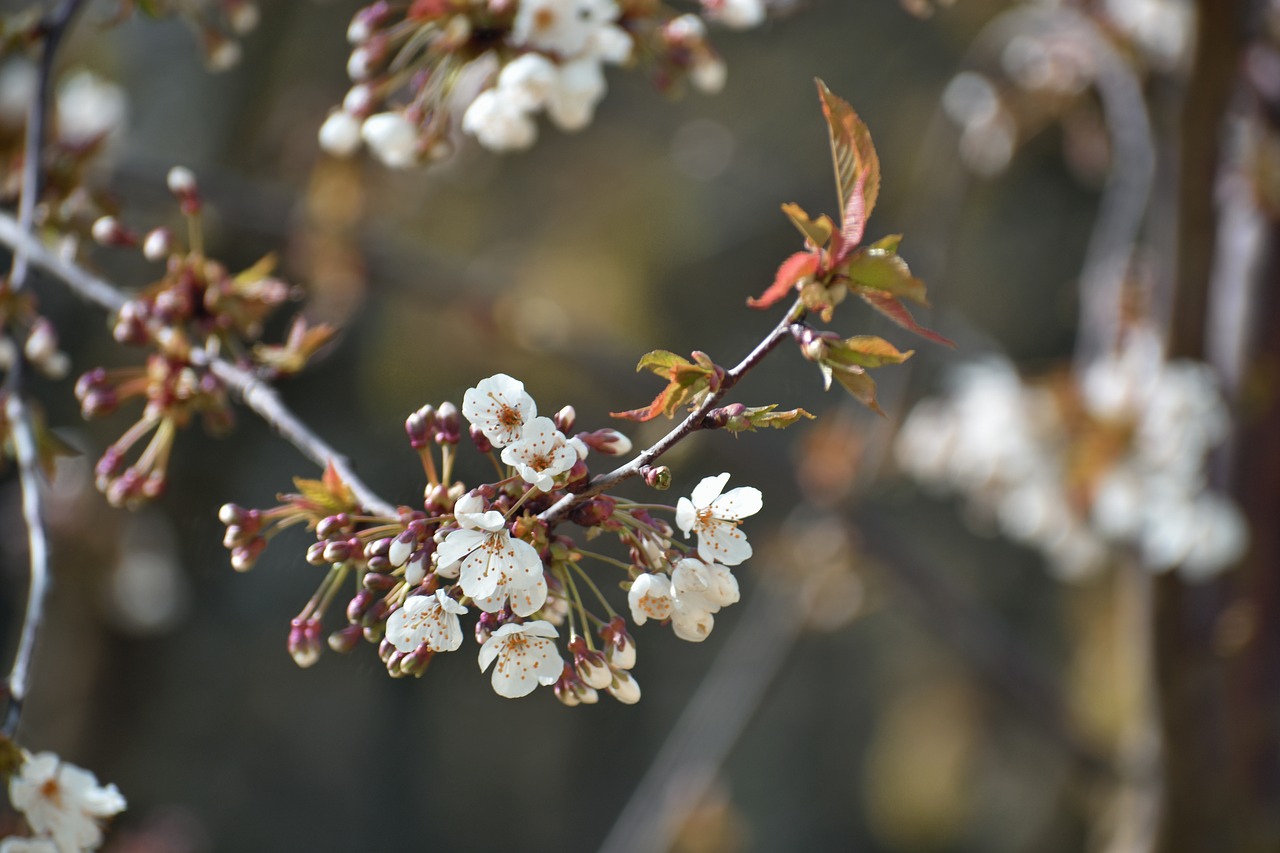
320, 0, 765, 169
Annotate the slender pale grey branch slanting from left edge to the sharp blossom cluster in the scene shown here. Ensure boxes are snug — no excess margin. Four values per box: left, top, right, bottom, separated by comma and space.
0, 208, 396, 515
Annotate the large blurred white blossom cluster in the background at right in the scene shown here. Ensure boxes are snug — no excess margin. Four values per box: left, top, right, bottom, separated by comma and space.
896, 330, 1248, 579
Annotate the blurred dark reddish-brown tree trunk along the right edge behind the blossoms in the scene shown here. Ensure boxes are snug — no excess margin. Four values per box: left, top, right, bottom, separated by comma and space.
1155, 0, 1280, 853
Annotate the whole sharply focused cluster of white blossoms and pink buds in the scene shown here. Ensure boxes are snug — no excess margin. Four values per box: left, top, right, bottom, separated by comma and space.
221, 374, 762, 706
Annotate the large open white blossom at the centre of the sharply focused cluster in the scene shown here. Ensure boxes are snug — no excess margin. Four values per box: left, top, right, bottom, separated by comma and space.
436, 510, 547, 616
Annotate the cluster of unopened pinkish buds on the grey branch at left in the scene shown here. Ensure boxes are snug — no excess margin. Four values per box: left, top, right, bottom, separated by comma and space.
76, 167, 333, 506
